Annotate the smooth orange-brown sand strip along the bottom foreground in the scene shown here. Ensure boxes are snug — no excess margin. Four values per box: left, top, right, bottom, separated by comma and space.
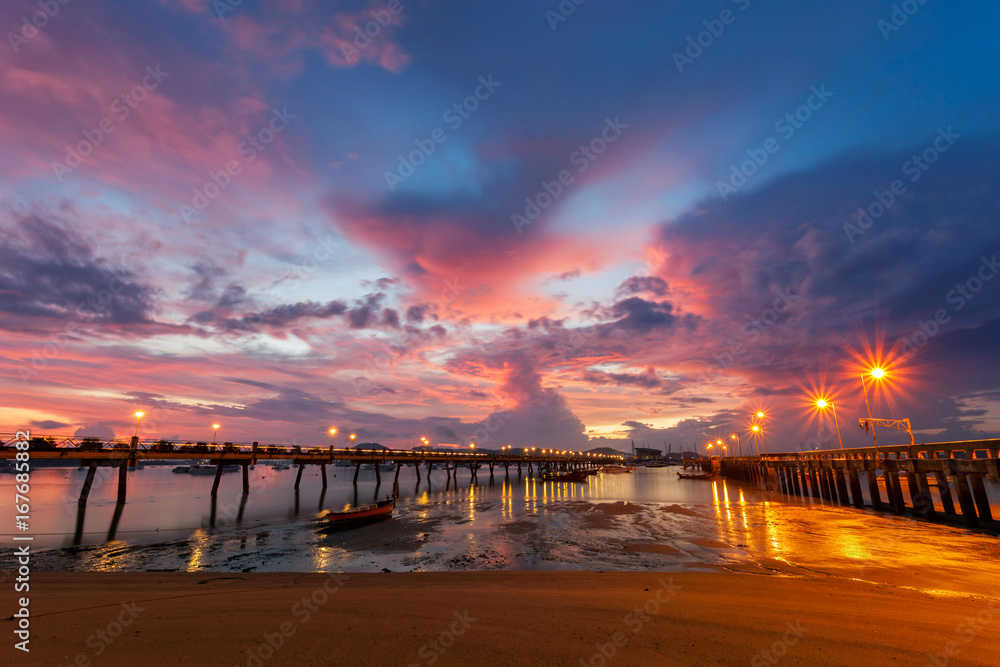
7, 572, 1000, 666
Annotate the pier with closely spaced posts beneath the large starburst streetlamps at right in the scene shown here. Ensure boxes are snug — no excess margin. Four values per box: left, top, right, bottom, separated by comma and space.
717, 440, 1000, 528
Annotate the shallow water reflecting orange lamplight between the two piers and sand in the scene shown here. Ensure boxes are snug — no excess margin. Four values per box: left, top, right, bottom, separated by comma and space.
0, 466, 1000, 591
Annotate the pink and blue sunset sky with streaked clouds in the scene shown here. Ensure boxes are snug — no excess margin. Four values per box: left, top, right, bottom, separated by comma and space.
0, 0, 1000, 451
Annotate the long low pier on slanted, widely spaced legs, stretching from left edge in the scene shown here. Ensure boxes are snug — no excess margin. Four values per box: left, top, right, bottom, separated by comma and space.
0, 437, 618, 507
